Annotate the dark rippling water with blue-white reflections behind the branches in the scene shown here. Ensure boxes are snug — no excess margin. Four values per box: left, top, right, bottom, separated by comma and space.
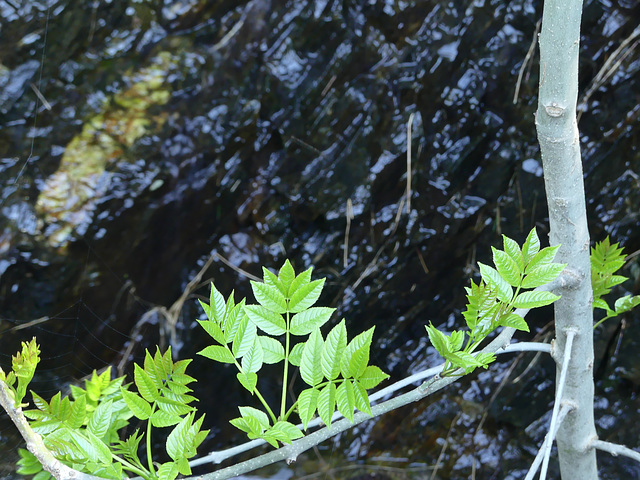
0, 0, 640, 479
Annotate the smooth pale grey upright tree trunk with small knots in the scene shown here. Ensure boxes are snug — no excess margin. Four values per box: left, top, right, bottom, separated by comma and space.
536, 0, 598, 480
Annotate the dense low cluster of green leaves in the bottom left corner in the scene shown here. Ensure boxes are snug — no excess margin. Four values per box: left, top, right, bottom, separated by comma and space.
18, 349, 208, 480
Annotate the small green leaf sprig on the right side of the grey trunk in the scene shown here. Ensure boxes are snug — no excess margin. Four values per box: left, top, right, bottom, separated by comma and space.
591, 237, 640, 328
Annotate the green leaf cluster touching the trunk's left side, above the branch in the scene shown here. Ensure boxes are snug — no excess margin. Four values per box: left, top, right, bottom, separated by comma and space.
425, 229, 566, 376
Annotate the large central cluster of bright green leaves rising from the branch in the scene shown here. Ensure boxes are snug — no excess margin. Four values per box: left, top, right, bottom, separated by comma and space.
199, 260, 388, 447
